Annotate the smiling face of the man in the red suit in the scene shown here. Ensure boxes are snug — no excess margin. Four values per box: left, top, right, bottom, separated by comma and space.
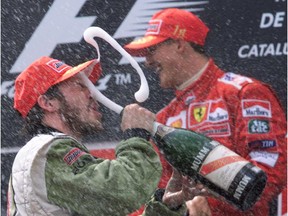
146, 39, 181, 88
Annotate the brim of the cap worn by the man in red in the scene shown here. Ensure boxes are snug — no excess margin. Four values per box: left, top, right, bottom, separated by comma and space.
124, 35, 167, 57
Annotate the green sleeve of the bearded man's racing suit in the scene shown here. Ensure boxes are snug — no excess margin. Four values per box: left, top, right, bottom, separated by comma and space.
45, 137, 162, 216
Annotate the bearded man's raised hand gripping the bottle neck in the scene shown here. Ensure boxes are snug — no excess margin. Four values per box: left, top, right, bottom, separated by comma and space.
121, 104, 156, 132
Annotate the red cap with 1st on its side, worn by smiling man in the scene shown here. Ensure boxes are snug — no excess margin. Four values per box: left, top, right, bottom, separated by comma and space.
124, 8, 209, 56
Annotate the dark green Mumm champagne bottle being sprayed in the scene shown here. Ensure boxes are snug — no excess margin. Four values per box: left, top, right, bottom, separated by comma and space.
153, 122, 267, 211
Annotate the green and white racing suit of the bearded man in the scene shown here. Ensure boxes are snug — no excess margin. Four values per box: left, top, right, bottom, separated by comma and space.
7, 129, 162, 216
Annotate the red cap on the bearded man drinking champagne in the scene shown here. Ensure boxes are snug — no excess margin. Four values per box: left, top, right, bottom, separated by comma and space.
14, 56, 102, 118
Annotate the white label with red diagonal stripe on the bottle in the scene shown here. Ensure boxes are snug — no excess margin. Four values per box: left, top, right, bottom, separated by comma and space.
199, 141, 249, 191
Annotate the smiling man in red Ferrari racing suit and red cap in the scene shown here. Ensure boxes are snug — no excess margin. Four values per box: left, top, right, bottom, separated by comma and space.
124, 8, 287, 216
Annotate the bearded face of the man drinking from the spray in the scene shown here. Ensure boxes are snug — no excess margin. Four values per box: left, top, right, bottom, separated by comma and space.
59, 77, 103, 135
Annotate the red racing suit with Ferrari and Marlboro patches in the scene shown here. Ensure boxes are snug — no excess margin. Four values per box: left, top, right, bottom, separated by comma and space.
157, 59, 287, 216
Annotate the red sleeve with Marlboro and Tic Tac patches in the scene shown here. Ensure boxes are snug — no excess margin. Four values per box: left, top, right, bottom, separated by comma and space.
209, 82, 287, 215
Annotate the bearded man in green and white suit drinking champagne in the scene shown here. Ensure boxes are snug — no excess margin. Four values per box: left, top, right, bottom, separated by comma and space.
7, 57, 162, 216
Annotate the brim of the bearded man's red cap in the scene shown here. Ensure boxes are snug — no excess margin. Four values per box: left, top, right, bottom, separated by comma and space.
54, 59, 102, 84
